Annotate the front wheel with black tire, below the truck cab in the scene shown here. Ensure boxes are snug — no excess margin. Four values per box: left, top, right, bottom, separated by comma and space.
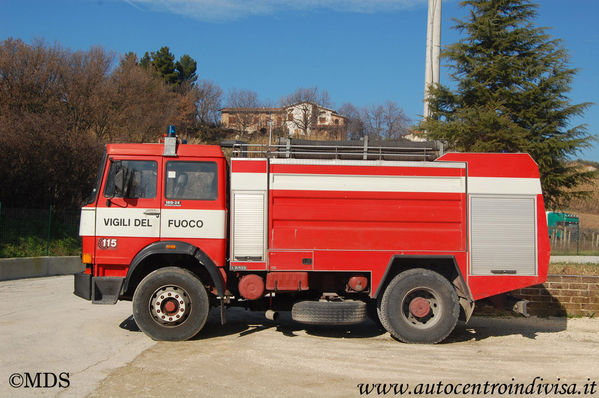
133, 267, 210, 341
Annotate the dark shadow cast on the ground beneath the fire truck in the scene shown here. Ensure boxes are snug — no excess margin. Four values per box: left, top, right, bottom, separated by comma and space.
119, 308, 567, 344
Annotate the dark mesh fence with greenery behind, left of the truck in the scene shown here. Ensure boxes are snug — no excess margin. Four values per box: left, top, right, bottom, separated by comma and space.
0, 203, 81, 257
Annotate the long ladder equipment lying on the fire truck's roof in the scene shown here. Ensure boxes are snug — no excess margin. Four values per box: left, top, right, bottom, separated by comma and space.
221, 137, 443, 161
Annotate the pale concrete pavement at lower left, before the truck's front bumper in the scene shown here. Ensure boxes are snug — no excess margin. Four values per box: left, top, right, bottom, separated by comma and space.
0, 276, 155, 397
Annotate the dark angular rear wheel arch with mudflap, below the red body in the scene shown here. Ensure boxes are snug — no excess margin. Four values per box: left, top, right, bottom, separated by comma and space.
373, 254, 474, 321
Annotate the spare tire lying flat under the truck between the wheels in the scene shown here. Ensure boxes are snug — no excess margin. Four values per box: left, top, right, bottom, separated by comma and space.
291, 300, 366, 325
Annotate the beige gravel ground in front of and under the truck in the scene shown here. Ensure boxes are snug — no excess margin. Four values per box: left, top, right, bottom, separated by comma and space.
91, 310, 599, 397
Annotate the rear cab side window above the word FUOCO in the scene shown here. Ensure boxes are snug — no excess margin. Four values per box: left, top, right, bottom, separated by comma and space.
164, 161, 218, 200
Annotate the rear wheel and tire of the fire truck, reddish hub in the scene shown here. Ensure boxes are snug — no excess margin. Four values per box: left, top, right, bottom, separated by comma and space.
378, 268, 460, 344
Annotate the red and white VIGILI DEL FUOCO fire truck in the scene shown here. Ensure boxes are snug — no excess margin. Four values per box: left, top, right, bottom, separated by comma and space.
75, 129, 550, 343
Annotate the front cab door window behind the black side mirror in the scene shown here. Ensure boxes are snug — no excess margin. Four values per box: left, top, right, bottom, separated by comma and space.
104, 160, 158, 199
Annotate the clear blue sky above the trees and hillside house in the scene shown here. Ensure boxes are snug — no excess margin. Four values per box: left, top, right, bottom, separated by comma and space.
0, 0, 599, 162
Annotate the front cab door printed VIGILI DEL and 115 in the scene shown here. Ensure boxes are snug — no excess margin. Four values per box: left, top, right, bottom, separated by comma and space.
95, 156, 162, 276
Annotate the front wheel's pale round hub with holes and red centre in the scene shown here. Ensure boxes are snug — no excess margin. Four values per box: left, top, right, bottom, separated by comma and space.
150, 286, 190, 325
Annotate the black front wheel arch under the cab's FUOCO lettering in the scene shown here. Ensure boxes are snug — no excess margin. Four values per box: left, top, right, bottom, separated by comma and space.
121, 241, 225, 299
